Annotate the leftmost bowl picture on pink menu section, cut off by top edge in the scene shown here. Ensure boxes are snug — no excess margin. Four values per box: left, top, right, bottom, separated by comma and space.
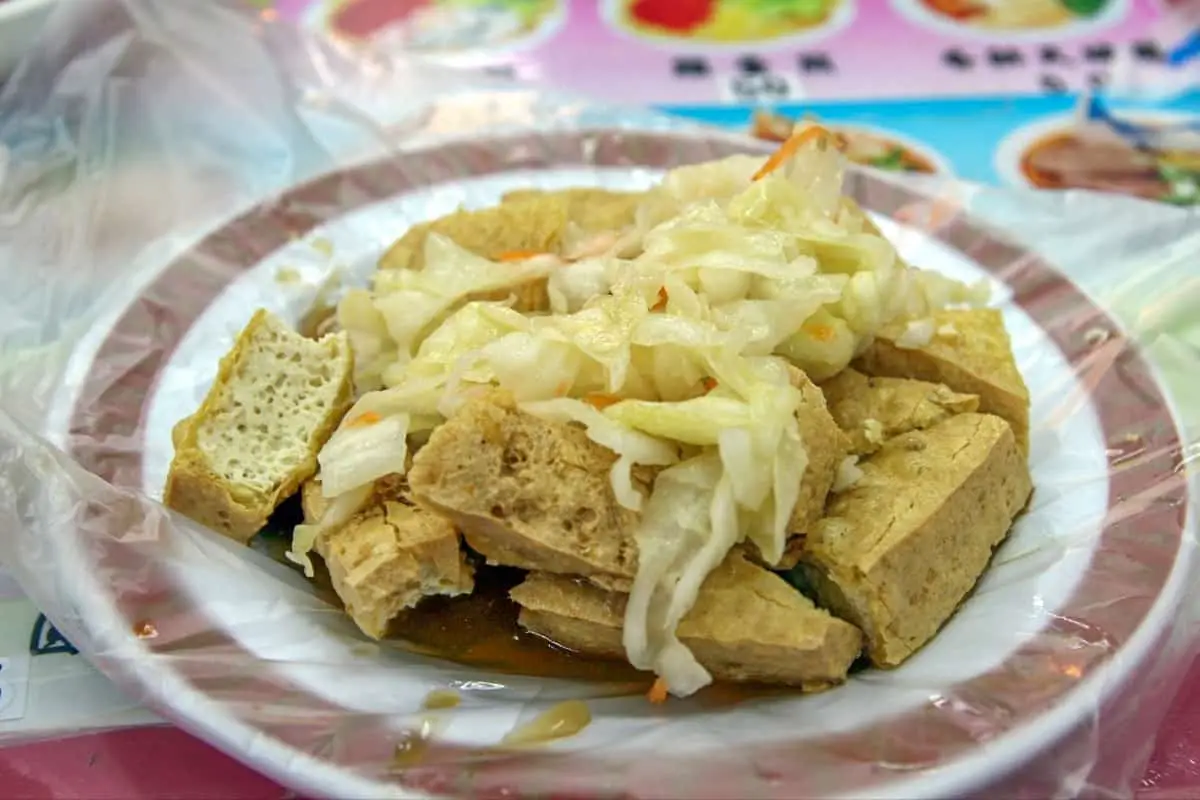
312, 0, 565, 54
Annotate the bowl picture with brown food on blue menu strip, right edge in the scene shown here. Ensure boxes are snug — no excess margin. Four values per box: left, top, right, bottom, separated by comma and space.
996, 113, 1200, 205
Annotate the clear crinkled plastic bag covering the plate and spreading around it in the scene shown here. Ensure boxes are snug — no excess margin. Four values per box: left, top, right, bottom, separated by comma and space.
0, 0, 1200, 798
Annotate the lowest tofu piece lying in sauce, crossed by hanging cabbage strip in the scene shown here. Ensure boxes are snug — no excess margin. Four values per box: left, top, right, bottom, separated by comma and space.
511, 553, 862, 690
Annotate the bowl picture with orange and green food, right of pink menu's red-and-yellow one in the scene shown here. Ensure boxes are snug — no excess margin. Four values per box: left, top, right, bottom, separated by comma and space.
893, 0, 1129, 38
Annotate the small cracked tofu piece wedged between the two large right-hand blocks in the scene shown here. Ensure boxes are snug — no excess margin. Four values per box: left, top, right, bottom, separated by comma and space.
821, 369, 979, 456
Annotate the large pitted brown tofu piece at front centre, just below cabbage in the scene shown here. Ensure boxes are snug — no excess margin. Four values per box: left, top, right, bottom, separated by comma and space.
408, 391, 650, 581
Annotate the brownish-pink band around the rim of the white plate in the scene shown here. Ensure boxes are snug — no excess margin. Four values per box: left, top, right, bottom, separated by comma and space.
71, 130, 1188, 798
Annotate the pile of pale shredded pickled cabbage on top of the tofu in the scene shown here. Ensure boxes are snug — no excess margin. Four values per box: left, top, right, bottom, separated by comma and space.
321, 130, 986, 696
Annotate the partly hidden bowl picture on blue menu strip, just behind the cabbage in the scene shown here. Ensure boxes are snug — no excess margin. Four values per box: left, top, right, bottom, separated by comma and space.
750, 110, 954, 175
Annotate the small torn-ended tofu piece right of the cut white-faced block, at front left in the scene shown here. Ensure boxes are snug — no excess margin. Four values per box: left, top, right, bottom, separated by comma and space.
316, 499, 475, 639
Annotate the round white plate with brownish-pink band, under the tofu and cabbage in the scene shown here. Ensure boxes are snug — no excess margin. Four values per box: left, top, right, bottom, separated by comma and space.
43, 130, 1193, 799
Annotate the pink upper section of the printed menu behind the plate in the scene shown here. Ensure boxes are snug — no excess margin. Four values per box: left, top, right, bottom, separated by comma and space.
276, 0, 1171, 106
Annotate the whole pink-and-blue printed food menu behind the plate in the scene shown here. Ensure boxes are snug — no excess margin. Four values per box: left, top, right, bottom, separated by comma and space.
258, 0, 1200, 205
